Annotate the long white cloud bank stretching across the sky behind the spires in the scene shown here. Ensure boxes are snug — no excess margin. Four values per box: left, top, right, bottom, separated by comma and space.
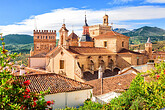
0, 6, 165, 35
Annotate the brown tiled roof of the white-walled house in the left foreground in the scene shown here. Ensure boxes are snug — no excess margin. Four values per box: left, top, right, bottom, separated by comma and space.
17, 73, 93, 94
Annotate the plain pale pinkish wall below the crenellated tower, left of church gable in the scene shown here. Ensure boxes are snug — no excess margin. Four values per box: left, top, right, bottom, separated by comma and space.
30, 58, 46, 68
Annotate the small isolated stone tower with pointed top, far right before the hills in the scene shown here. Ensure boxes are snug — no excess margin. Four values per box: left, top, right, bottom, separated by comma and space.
145, 37, 152, 59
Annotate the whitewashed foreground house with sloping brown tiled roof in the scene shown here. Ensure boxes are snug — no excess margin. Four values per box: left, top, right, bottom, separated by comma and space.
20, 73, 93, 110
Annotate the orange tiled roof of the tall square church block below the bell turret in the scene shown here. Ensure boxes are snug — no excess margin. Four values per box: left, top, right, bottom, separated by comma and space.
94, 31, 128, 39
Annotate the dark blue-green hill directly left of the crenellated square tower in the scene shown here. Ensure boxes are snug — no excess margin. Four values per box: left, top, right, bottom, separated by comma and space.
3, 34, 33, 44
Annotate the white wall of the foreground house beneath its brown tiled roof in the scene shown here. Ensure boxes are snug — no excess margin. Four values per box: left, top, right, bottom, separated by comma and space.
45, 89, 92, 110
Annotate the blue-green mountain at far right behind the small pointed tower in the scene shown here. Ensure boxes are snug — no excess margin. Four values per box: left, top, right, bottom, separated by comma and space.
123, 26, 165, 44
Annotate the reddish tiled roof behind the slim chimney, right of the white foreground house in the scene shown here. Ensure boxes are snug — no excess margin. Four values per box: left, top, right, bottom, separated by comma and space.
86, 73, 136, 95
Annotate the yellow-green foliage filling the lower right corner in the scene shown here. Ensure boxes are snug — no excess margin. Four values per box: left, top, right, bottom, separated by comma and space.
66, 61, 165, 110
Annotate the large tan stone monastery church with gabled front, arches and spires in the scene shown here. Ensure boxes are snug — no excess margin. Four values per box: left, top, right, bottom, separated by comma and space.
29, 15, 148, 81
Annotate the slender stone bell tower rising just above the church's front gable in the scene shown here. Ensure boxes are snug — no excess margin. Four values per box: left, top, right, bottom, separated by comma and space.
59, 24, 69, 48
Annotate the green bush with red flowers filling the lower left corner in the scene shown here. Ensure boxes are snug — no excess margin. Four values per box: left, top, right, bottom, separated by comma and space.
0, 36, 53, 110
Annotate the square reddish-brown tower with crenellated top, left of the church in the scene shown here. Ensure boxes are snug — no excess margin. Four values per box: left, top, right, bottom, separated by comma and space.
31, 30, 56, 56
